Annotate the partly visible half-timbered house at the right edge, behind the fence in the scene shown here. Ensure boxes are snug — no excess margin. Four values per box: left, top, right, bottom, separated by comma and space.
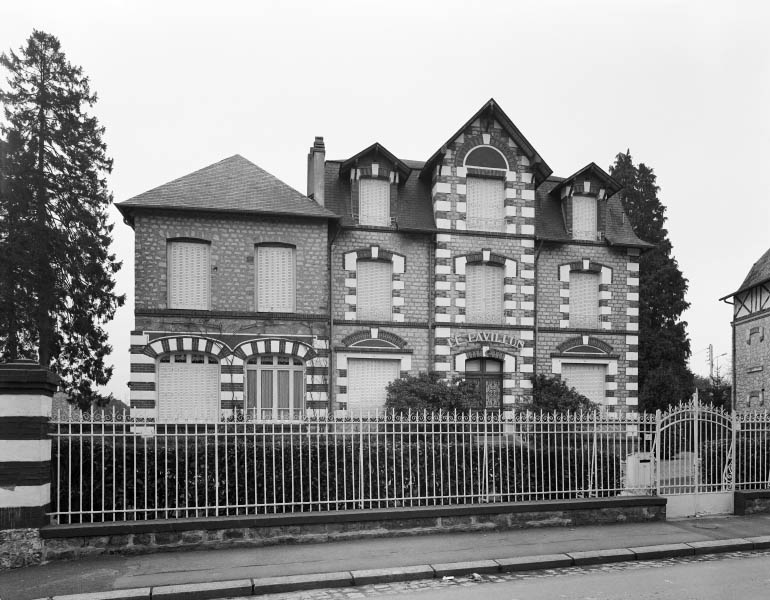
720, 250, 770, 410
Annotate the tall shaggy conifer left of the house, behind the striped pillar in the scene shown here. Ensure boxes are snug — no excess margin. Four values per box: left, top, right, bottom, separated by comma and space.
0, 31, 124, 406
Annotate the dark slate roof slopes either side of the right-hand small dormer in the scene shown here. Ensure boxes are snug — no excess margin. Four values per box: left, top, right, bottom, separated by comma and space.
535, 176, 653, 248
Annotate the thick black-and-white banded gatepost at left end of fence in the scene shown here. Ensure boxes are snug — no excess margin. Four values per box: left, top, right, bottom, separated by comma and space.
0, 360, 59, 570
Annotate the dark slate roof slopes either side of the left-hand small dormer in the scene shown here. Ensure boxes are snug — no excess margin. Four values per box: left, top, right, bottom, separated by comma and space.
324, 159, 436, 231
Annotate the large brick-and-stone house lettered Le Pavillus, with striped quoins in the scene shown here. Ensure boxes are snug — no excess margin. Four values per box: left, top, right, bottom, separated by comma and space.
117, 100, 648, 420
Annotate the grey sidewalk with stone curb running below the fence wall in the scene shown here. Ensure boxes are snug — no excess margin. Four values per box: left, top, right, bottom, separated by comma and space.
0, 515, 770, 600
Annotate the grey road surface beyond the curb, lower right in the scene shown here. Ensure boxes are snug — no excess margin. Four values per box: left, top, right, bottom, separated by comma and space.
260, 552, 770, 600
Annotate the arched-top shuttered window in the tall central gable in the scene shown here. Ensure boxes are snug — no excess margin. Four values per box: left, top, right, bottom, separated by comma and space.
465, 146, 508, 231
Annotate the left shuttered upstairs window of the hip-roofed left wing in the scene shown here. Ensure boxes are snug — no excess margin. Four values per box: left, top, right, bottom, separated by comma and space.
166, 240, 211, 310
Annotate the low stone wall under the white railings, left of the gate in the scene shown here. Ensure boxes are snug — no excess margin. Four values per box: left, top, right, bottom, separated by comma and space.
41, 496, 666, 562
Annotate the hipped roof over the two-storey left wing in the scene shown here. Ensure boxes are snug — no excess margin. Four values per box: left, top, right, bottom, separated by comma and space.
116, 154, 337, 226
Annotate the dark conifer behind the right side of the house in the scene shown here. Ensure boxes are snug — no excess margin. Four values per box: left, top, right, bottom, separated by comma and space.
610, 151, 694, 410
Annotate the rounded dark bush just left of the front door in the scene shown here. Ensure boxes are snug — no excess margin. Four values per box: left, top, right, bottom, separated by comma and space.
385, 372, 484, 413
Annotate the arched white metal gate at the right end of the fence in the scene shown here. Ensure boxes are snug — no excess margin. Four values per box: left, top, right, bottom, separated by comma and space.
653, 392, 735, 517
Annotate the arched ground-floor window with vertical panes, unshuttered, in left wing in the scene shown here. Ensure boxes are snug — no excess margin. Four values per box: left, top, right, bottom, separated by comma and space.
246, 354, 305, 421
